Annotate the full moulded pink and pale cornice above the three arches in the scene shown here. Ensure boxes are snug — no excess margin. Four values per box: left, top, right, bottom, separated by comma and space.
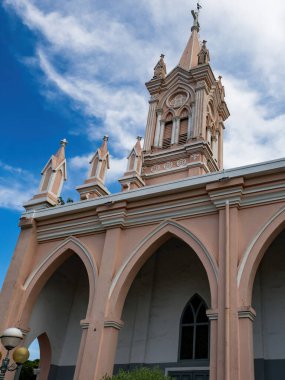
21, 159, 285, 241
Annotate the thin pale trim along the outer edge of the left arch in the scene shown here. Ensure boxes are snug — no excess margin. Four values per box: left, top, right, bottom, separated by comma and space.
23, 236, 98, 290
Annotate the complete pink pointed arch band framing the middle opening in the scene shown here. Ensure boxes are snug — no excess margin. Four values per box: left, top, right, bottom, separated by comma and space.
108, 220, 218, 319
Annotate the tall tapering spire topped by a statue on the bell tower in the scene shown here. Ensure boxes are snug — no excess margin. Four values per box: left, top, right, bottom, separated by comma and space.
178, 3, 201, 71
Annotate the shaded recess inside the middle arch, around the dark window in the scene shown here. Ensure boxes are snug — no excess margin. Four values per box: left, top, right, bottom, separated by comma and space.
115, 237, 211, 379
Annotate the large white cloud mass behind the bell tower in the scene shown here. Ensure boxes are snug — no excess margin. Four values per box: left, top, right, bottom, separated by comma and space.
4, 0, 285, 199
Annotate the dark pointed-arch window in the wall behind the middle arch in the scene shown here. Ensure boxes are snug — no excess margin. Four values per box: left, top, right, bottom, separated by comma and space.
179, 294, 209, 360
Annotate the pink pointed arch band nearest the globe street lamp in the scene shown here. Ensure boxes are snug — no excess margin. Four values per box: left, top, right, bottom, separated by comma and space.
18, 236, 98, 326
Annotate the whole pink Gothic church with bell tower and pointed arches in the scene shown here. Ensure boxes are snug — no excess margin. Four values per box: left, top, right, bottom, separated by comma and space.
0, 11, 285, 380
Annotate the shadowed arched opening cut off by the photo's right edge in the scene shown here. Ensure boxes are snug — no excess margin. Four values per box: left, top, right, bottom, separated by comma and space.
252, 230, 285, 380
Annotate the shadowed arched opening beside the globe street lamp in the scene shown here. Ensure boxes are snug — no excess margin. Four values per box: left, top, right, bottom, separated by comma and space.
27, 252, 89, 380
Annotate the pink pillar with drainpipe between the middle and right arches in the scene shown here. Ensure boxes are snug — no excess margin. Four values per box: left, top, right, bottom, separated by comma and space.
216, 201, 241, 380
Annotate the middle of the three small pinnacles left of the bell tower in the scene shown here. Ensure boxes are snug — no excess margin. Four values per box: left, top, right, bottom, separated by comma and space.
76, 136, 110, 200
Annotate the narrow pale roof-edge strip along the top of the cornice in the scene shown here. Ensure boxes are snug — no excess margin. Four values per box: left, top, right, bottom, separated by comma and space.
22, 158, 285, 219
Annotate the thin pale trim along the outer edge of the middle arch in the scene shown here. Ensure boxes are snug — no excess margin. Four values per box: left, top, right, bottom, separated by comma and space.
108, 220, 219, 299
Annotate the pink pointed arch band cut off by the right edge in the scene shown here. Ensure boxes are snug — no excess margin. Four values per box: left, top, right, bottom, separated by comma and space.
238, 206, 285, 306
